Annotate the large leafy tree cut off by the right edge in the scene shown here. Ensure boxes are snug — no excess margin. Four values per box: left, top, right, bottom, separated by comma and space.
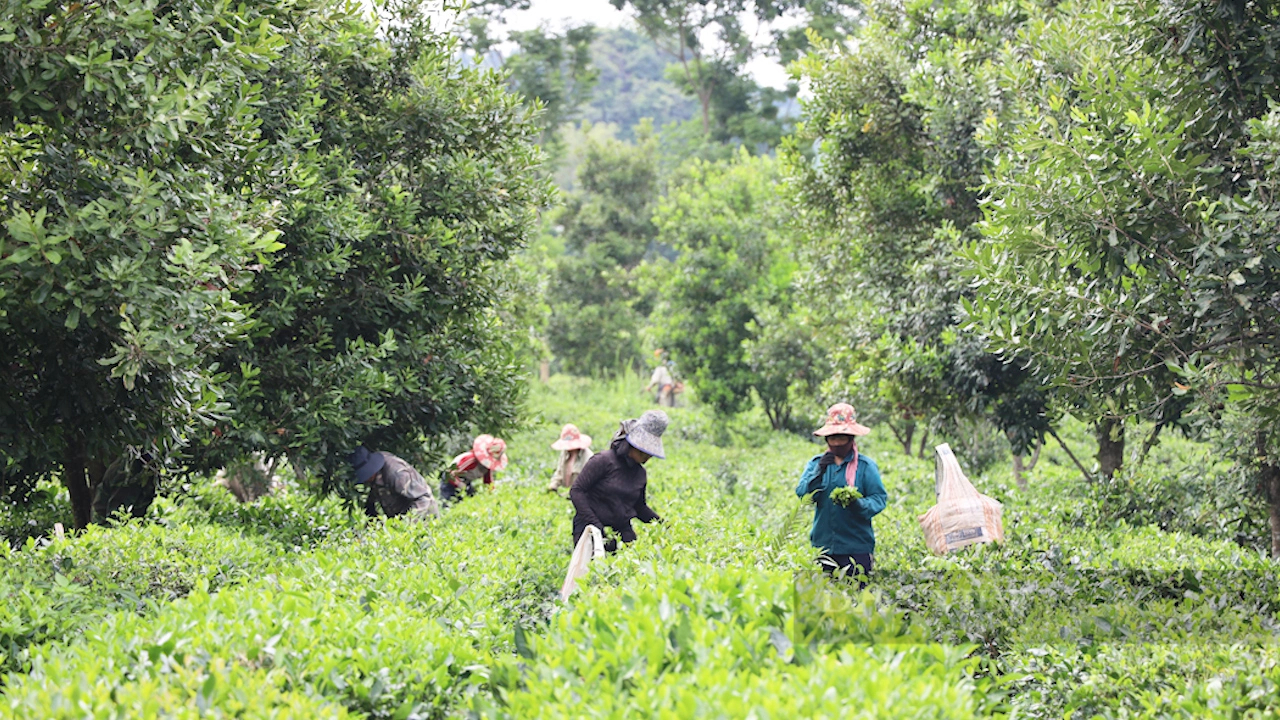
970, 1, 1280, 555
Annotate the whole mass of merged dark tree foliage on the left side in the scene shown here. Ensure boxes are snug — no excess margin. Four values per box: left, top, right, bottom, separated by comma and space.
0, 0, 548, 515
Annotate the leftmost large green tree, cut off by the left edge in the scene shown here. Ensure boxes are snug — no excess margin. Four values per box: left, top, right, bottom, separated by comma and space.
0, 0, 293, 525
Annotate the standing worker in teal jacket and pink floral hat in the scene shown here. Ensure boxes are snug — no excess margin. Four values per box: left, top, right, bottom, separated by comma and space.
796, 402, 888, 587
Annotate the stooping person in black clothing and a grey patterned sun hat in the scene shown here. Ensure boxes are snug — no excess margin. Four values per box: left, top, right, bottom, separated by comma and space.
568, 410, 668, 552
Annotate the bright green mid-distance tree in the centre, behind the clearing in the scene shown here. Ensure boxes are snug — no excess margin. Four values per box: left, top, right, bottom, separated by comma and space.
652, 152, 814, 420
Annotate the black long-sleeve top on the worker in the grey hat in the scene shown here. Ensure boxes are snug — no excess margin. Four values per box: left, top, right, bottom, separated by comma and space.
568, 443, 660, 543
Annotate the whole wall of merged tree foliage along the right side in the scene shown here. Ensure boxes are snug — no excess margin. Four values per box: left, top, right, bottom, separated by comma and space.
786, 0, 1280, 543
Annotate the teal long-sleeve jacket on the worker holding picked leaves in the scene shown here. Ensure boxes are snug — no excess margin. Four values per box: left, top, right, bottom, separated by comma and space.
796, 454, 888, 555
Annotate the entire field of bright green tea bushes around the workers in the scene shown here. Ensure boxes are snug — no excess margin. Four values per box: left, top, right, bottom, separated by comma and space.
0, 377, 1280, 719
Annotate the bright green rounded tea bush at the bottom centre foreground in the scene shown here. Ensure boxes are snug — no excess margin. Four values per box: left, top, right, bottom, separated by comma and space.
474, 557, 998, 717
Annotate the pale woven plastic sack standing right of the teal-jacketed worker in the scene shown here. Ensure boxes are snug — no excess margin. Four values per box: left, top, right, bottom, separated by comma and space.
920, 443, 1005, 555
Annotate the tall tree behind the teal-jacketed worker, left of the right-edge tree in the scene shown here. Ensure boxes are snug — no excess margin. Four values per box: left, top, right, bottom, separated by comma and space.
783, 1, 1047, 466
